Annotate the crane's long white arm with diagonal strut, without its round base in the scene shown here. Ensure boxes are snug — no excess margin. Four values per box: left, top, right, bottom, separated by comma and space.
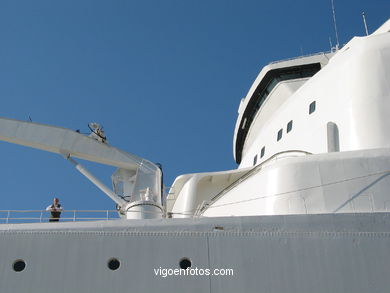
0, 118, 162, 205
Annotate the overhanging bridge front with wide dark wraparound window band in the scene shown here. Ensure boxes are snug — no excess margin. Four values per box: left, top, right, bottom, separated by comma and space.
233, 52, 333, 164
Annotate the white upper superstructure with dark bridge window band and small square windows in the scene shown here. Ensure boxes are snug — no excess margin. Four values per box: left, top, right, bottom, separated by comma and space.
233, 22, 390, 168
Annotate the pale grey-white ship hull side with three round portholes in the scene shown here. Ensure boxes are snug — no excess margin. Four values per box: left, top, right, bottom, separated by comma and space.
0, 213, 390, 293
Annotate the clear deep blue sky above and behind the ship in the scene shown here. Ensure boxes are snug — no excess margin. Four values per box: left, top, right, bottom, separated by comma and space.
0, 0, 390, 210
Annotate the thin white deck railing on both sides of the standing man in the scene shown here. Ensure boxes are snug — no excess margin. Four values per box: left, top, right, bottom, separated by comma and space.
0, 210, 119, 224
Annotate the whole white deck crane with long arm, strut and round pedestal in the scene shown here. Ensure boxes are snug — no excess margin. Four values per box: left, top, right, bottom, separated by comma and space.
0, 118, 164, 218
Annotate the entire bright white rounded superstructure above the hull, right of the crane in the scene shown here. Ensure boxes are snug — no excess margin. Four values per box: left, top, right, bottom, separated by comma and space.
171, 18, 390, 217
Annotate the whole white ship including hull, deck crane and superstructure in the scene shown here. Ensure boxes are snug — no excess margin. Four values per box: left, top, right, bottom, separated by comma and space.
0, 20, 390, 293
